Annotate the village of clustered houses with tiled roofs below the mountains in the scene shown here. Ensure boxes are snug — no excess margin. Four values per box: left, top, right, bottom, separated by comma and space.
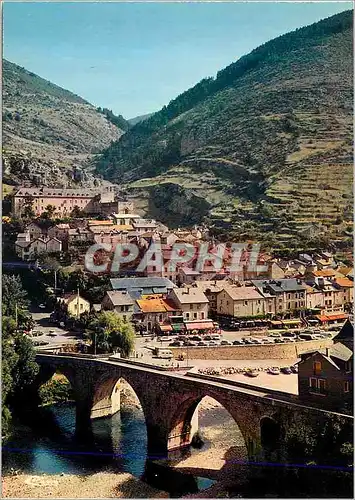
4, 186, 353, 334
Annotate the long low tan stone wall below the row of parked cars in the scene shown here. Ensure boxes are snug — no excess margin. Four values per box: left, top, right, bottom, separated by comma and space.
169, 339, 333, 360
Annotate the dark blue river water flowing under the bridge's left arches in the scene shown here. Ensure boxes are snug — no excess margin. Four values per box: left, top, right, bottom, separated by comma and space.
3, 404, 213, 498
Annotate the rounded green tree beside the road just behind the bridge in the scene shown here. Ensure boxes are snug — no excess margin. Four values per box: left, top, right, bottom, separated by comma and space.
87, 311, 134, 358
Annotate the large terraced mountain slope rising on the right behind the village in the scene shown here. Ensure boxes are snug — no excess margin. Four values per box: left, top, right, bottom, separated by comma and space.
96, 11, 352, 245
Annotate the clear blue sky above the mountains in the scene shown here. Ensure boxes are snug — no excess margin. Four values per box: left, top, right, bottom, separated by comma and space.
3, 1, 352, 118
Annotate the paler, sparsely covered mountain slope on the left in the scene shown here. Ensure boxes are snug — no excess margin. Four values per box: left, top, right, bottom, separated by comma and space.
3, 60, 128, 185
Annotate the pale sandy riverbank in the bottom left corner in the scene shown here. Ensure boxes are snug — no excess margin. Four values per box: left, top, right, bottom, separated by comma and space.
2, 472, 169, 498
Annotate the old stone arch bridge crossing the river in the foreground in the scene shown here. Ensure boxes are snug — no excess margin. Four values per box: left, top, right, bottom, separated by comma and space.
35, 354, 352, 462
